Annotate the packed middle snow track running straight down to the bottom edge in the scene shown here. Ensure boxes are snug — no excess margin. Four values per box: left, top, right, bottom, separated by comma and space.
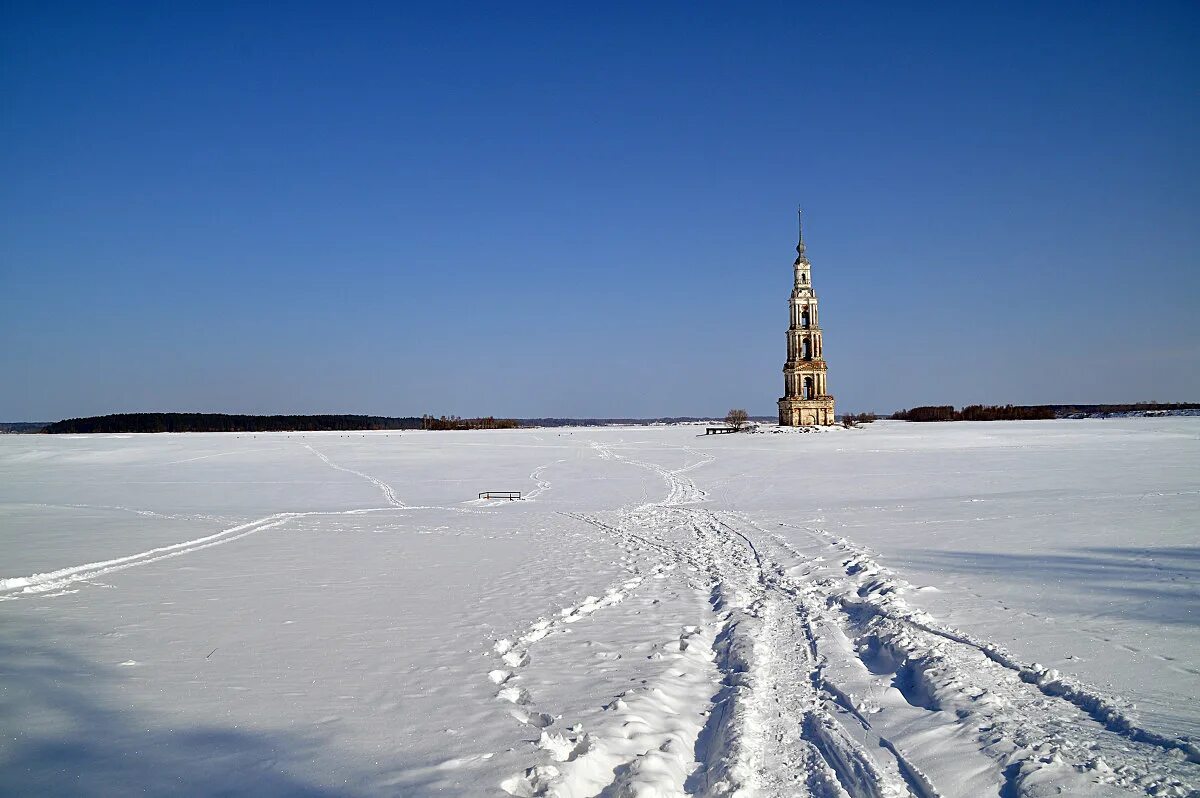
671, 508, 916, 798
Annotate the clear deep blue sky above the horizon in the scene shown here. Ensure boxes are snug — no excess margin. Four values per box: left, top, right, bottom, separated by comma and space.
0, 0, 1200, 420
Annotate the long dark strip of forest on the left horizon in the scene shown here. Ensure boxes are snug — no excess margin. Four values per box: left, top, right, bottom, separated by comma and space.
44, 413, 421, 434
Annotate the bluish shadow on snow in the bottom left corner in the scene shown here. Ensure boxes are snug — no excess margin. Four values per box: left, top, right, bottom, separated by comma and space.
0, 618, 364, 798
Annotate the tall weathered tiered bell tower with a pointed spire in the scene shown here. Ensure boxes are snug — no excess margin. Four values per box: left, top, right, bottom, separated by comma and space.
779, 208, 834, 427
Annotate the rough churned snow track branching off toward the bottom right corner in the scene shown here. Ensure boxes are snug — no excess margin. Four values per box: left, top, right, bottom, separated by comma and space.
768, 522, 1198, 797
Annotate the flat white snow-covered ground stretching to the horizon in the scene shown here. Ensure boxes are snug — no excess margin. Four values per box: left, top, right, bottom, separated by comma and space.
0, 418, 1200, 798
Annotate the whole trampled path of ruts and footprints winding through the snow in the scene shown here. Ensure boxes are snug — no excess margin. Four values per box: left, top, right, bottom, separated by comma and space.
488, 442, 1200, 798
